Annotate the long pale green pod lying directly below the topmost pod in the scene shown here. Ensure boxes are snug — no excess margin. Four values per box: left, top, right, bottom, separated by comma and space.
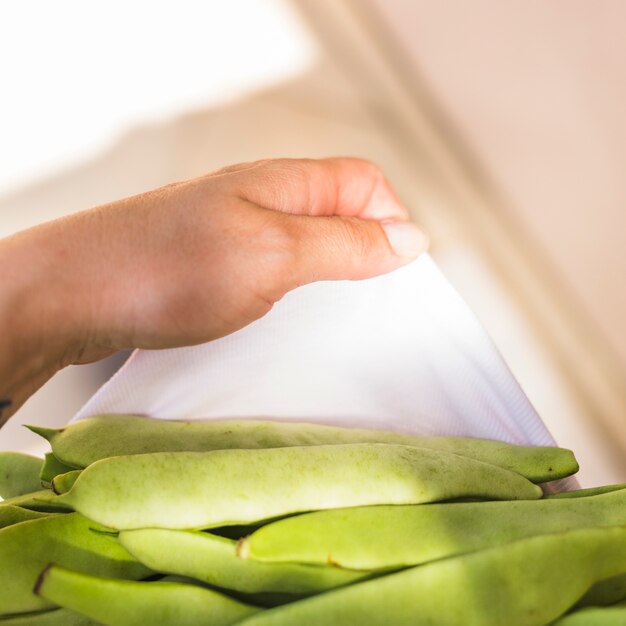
58, 444, 541, 530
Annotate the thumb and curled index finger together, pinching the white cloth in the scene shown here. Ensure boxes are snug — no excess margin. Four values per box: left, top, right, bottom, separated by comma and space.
212, 157, 428, 292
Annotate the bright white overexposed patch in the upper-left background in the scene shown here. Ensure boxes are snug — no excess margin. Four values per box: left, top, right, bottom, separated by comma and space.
0, 0, 316, 194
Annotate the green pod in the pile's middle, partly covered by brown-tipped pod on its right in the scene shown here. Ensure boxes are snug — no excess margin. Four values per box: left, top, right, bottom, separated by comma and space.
119, 529, 364, 595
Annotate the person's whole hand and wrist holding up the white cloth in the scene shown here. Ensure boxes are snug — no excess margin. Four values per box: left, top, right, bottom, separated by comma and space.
0, 158, 427, 423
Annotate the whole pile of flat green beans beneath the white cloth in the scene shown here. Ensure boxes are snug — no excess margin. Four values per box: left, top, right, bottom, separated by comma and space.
0, 415, 626, 626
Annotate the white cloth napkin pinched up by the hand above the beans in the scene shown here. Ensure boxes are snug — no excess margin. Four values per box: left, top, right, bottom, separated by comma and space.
75, 255, 554, 454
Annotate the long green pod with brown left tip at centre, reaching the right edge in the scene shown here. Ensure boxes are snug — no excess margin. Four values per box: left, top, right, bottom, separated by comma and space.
239, 490, 626, 570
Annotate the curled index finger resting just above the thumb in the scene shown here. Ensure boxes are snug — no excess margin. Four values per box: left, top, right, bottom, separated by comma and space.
219, 157, 409, 221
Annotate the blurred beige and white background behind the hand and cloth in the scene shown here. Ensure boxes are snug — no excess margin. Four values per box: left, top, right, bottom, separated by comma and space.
0, 0, 626, 486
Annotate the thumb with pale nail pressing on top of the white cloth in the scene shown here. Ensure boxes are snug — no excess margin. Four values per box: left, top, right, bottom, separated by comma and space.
285, 215, 428, 288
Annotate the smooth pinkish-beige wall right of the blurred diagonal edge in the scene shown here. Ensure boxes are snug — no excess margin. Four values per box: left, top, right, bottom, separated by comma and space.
372, 0, 626, 370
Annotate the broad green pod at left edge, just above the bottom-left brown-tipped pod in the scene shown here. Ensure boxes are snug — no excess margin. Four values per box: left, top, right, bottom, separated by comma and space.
0, 513, 151, 615
